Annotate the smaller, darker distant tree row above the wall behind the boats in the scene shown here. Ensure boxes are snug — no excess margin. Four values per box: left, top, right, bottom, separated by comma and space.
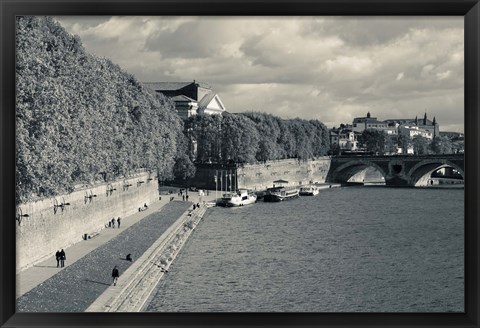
185, 112, 330, 163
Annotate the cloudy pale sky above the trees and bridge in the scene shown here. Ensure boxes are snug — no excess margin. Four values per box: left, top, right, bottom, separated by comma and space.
56, 16, 464, 132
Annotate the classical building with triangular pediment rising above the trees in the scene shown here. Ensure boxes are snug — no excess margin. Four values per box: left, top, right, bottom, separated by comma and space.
143, 80, 226, 120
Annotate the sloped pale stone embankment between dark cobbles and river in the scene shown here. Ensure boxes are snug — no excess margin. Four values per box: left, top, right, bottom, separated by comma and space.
86, 206, 206, 312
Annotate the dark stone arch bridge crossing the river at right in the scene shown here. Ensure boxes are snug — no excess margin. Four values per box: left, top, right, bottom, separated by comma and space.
326, 154, 465, 187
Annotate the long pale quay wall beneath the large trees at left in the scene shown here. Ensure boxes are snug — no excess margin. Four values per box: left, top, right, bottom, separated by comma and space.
16, 172, 159, 273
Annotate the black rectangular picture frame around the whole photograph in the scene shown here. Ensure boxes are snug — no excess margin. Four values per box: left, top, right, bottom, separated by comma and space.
0, 0, 480, 327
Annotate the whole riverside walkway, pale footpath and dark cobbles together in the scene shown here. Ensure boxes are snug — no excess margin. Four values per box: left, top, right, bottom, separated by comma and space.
17, 188, 213, 312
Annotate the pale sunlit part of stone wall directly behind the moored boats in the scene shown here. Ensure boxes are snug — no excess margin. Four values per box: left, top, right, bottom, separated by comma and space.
237, 157, 331, 190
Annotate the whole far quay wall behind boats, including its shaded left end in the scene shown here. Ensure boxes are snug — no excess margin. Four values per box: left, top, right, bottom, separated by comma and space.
189, 157, 331, 191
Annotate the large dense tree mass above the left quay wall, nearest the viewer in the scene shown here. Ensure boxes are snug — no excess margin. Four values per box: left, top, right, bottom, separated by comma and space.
16, 16, 186, 203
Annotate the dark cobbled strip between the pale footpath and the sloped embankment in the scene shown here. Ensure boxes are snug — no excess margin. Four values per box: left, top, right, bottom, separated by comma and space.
17, 201, 191, 312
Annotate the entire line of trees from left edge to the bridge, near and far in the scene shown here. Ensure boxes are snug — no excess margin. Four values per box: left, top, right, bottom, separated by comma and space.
16, 16, 330, 203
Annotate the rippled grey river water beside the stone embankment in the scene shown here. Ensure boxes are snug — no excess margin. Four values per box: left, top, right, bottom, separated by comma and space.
146, 187, 464, 312
